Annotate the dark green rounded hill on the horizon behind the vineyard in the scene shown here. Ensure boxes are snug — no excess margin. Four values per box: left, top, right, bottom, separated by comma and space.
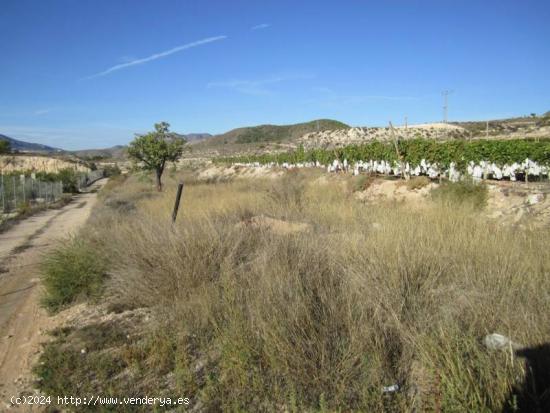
202, 119, 349, 145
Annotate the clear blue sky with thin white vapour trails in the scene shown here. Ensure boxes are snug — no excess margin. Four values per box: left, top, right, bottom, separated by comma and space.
0, 0, 550, 149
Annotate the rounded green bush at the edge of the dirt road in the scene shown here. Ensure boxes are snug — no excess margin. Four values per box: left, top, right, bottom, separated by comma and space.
42, 237, 106, 312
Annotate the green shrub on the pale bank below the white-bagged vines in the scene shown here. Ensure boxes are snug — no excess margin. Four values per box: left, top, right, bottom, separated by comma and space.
431, 180, 488, 209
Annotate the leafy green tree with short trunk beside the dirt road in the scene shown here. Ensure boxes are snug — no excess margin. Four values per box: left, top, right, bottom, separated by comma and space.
128, 122, 185, 191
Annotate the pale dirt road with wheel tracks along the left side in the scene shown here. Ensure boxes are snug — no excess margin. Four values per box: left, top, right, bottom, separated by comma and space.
0, 180, 105, 411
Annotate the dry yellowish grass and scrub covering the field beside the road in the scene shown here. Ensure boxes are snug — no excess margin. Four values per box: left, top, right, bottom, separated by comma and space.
36, 171, 550, 412
